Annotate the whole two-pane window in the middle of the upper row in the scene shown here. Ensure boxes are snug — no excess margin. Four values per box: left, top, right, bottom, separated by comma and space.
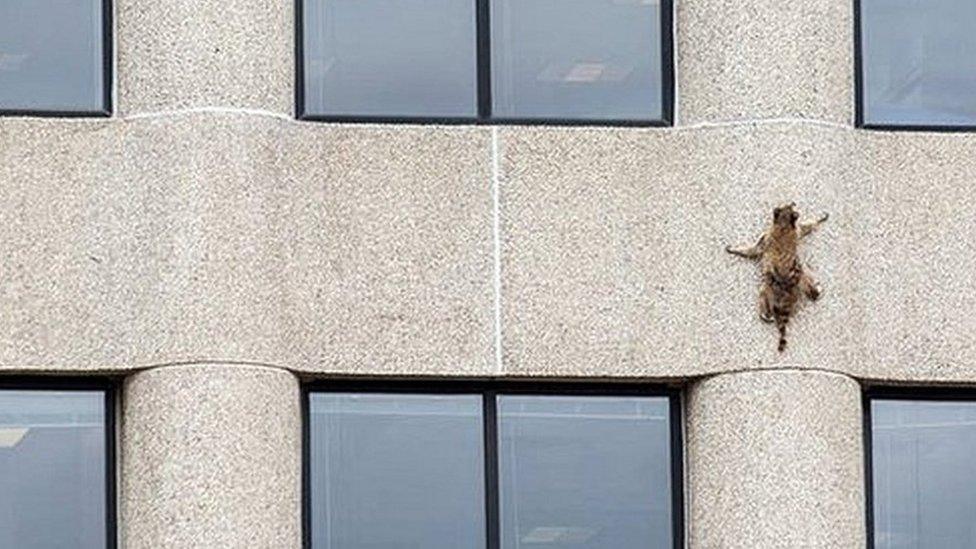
297, 0, 673, 125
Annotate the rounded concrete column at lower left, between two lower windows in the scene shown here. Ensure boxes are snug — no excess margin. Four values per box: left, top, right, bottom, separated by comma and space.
120, 364, 301, 549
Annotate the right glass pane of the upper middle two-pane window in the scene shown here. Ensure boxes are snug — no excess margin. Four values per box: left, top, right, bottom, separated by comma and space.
491, 0, 663, 120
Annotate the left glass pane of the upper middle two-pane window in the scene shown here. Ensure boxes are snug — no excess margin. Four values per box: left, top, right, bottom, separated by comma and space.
302, 0, 477, 117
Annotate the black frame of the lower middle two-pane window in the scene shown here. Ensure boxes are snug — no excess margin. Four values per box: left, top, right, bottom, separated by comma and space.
301, 379, 685, 549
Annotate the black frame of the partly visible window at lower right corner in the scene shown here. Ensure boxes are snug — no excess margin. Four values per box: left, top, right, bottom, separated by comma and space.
861, 386, 976, 549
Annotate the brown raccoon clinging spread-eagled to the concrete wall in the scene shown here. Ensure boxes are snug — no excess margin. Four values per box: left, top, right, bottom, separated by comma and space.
725, 204, 827, 352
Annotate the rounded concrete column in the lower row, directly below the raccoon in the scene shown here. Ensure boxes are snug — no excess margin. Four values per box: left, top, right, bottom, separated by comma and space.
687, 370, 865, 549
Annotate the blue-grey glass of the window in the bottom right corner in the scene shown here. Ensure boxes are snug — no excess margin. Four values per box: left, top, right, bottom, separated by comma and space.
871, 399, 976, 549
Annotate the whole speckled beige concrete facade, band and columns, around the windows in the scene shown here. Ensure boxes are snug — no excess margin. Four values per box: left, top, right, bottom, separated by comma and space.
0, 0, 976, 547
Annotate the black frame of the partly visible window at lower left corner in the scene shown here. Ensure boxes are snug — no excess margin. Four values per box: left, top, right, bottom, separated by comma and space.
0, 375, 119, 549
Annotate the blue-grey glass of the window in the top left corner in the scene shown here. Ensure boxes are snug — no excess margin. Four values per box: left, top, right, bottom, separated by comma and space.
0, 0, 106, 112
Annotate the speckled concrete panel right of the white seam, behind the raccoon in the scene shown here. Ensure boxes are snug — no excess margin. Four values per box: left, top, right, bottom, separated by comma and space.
500, 123, 976, 381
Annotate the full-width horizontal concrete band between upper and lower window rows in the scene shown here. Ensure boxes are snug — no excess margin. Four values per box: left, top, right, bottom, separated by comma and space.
0, 115, 976, 382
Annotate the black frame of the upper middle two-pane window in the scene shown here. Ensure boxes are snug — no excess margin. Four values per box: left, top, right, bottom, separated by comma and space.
295, 0, 675, 127
